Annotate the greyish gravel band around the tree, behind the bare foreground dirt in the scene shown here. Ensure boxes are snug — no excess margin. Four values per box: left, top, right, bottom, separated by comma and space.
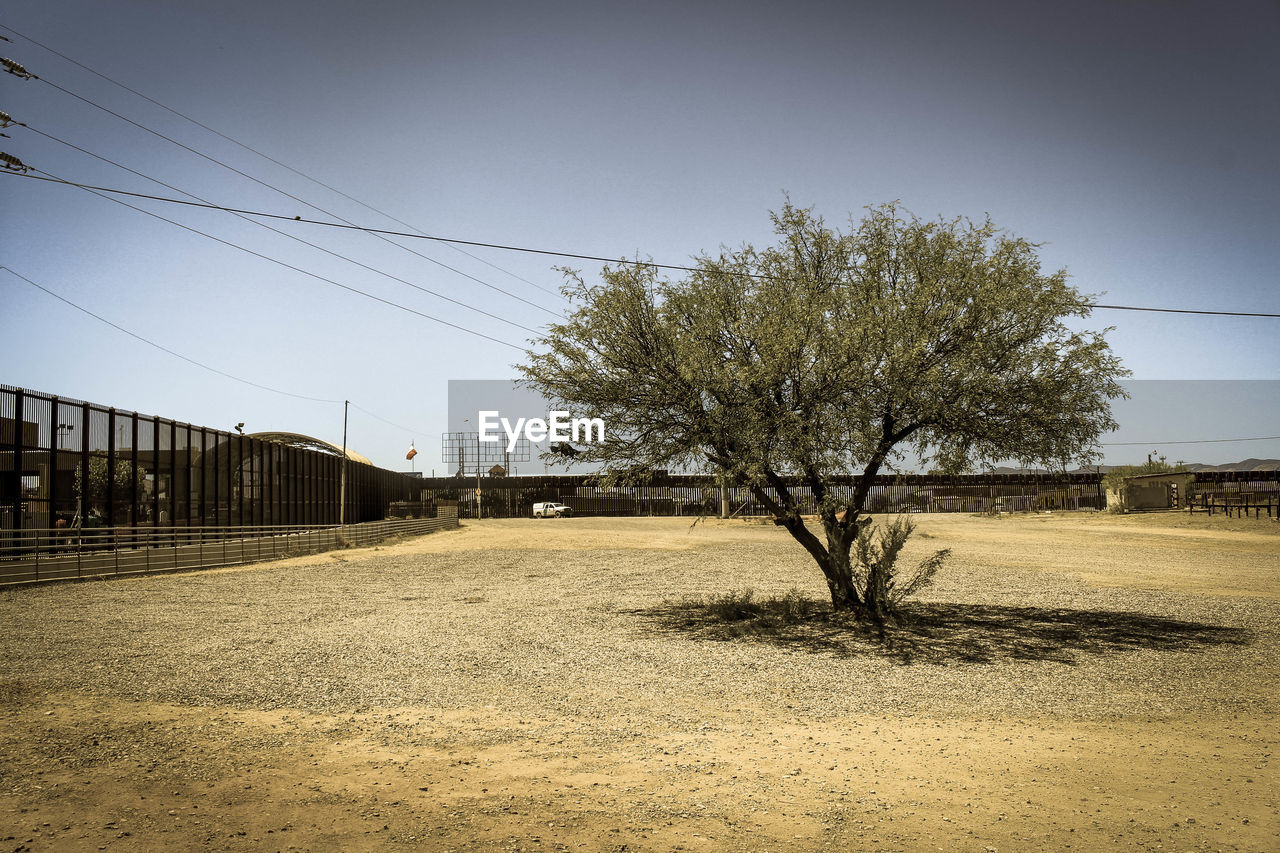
0, 520, 1280, 722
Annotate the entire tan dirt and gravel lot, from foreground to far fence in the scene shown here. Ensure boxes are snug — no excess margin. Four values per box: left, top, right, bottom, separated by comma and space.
0, 514, 1280, 852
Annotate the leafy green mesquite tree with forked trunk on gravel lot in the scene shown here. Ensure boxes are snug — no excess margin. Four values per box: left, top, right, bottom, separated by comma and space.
521, 202, 1128, 620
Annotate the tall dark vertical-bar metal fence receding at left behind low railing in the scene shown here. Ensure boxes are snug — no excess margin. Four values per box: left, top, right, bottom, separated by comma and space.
0, 386, 421, 535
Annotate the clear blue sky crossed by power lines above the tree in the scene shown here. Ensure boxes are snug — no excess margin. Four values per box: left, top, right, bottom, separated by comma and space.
0, 0, 1280, 470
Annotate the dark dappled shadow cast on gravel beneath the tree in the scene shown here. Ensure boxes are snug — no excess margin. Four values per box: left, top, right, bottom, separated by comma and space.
630, 593, 1253, 665
